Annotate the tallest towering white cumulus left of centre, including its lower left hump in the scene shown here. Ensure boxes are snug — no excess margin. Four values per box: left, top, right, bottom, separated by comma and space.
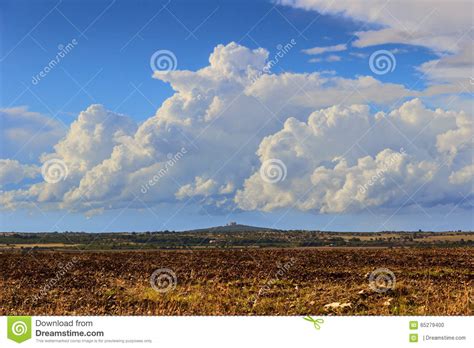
23, 43, 276, 211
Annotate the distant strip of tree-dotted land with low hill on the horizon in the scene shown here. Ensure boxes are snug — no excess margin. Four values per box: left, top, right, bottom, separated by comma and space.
0, 230, 474, 249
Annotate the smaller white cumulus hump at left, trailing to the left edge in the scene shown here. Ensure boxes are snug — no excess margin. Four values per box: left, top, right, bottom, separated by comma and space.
2, 105, 136, 209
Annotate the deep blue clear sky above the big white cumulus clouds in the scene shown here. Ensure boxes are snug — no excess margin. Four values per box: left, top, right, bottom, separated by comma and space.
2, 0, 434, 123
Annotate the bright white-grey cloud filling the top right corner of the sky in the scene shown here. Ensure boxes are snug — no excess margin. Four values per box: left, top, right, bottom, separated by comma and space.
277, 0, 474, 85
